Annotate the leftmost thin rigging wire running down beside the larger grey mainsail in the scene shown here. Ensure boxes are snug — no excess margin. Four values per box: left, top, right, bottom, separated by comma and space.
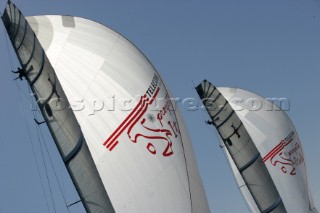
3, 25, 50, 212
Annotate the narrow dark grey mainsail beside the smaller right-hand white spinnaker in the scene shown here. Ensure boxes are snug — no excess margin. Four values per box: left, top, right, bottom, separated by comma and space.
196, 80, 286, 213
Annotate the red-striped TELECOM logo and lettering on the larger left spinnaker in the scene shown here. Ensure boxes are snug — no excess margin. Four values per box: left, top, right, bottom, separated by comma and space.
103, 75, 180, 157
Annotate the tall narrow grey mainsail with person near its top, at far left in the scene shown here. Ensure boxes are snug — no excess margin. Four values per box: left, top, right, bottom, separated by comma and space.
2, 1, 114, 213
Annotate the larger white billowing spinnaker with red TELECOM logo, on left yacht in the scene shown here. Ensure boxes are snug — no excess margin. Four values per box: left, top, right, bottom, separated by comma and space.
27, 16, 209, 212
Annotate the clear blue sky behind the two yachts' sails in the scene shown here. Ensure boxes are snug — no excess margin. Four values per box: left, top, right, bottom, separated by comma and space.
0, 0, 320, 213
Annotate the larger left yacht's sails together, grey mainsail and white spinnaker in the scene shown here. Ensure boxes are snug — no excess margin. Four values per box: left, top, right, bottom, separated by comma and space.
2, 2, 209, 213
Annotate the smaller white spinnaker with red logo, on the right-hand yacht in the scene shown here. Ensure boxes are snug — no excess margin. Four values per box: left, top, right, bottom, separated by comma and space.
218, 88, 317, 213
